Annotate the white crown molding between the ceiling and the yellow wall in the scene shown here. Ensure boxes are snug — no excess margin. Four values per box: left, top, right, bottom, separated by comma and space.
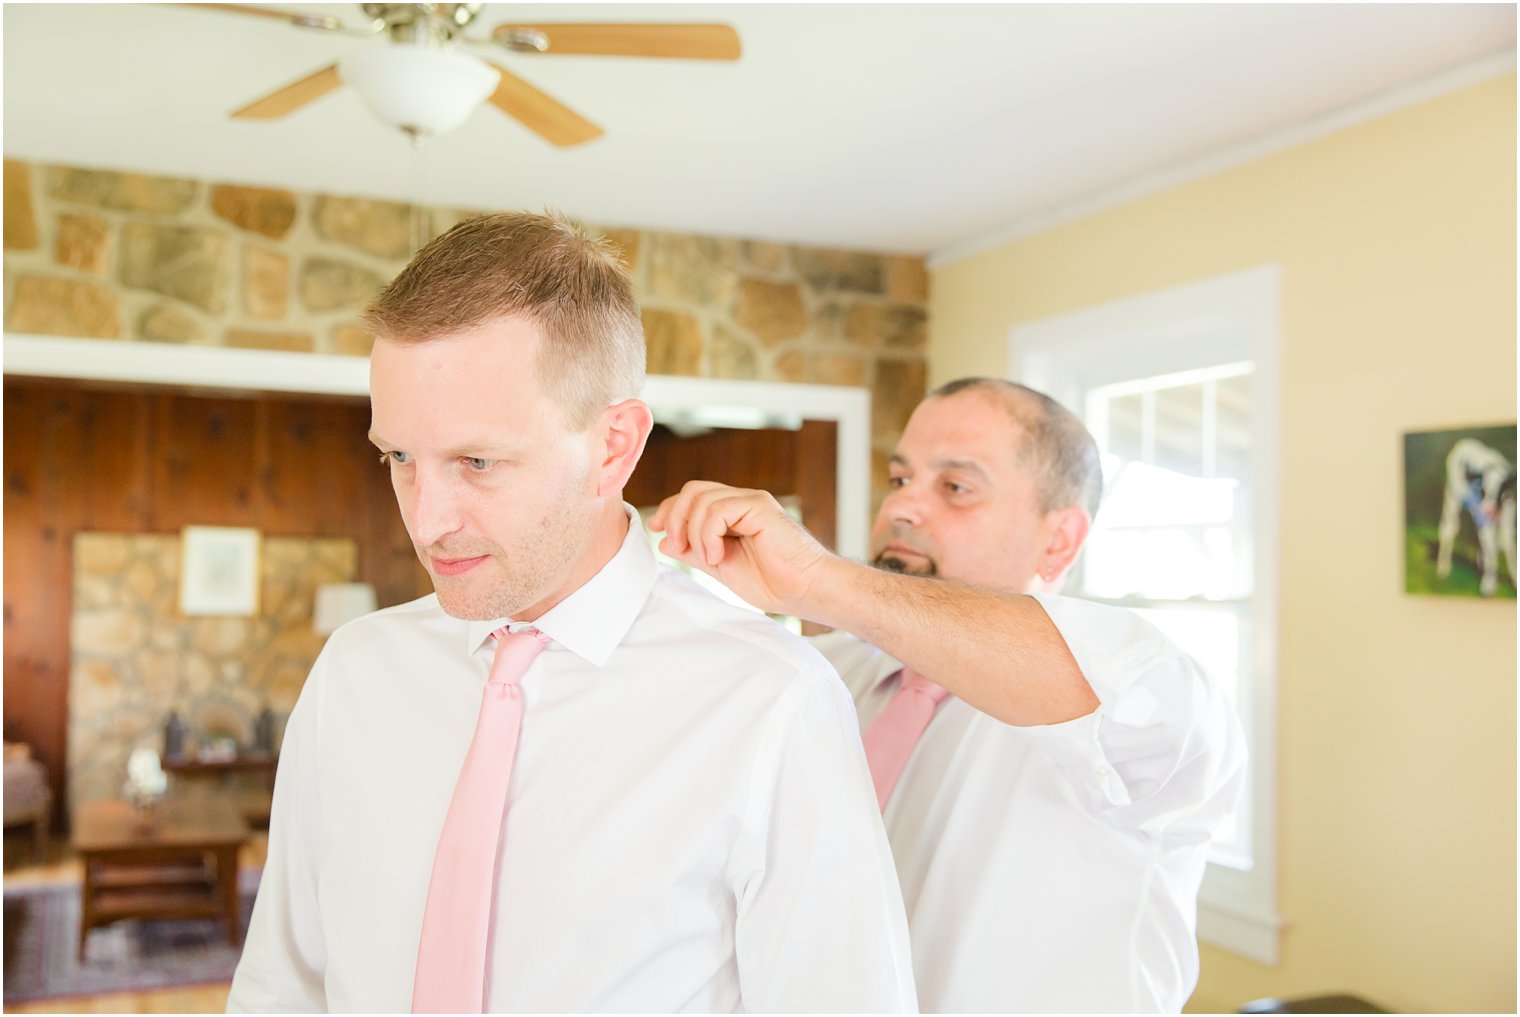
927, 47, 1515, 269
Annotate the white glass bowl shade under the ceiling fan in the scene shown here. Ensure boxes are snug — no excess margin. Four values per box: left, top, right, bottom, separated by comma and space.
337, 44, 500, 134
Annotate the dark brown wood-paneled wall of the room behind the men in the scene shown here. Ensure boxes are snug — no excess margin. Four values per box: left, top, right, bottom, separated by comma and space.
5, 379, 836, 819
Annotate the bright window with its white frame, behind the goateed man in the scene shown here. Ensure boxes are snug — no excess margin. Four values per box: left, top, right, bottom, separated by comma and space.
1011, 268, 1280, 964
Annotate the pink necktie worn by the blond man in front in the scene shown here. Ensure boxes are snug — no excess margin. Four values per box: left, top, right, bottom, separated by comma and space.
412, 628, 549, 1014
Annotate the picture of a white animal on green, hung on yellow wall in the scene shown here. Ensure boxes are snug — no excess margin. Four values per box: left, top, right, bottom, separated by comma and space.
1404, 424, 1515, 600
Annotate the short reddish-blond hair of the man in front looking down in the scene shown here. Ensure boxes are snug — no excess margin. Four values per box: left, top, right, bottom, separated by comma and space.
362, 211, 644, 430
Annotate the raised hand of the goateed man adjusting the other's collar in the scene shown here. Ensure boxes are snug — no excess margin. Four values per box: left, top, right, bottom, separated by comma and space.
649, 480, 839, 617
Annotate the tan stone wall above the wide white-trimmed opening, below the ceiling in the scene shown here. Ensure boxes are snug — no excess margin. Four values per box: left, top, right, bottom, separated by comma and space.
5, 160, 927, 504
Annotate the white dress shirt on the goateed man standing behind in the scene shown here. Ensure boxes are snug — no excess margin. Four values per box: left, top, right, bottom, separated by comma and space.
813, 594, 1245, 1014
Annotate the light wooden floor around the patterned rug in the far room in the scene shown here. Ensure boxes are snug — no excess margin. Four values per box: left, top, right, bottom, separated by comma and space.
5, 832, 269, 1014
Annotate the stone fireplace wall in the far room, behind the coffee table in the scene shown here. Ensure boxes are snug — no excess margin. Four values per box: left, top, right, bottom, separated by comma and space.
65, 532, 357, 804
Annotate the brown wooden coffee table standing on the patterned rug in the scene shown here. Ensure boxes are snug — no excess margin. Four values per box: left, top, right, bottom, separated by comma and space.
73, 797, 248, 959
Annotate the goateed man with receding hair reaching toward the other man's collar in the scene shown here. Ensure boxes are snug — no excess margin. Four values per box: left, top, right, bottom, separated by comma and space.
654, 379, 1245, 1012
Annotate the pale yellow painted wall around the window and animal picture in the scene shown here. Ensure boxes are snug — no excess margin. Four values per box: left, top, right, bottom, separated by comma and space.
929, 74, 1515, 1012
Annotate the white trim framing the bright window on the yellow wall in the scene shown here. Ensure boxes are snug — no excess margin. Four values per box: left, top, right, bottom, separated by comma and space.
1008, 265, 1283, 964
